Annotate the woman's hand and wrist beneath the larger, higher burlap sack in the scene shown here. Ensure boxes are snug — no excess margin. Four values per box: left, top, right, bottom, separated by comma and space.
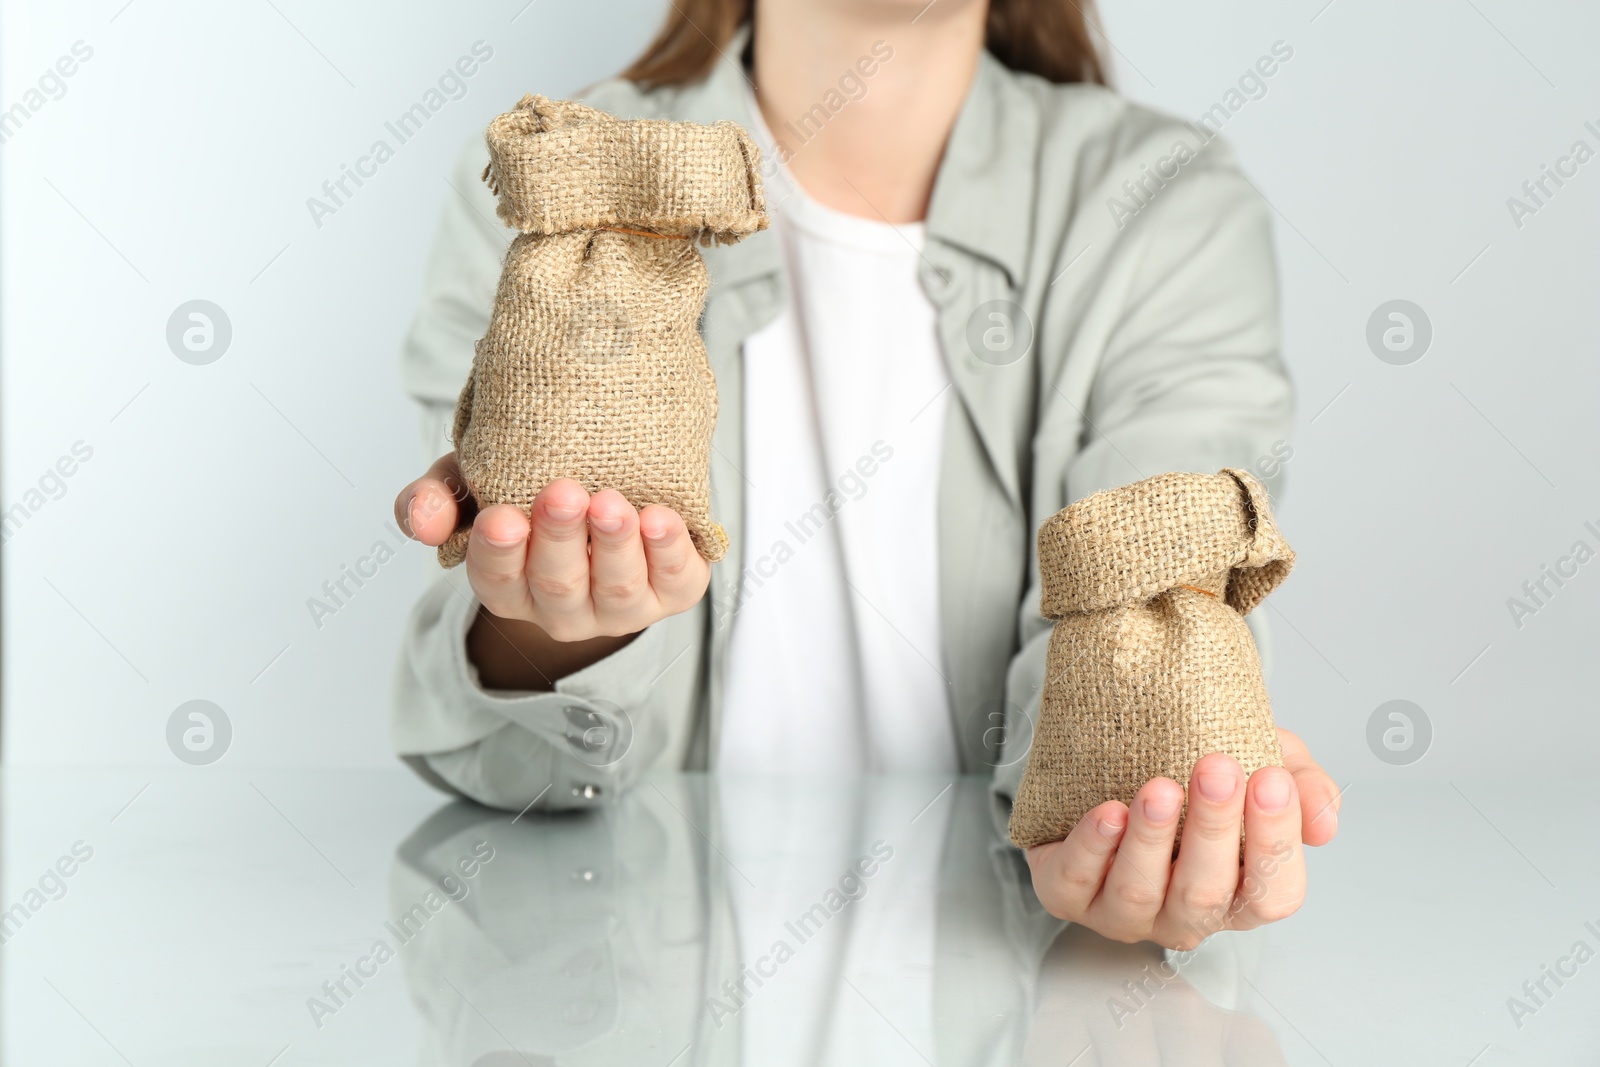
395, 453, 710, 689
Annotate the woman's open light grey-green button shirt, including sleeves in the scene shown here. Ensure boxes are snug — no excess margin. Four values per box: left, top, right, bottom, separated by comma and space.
392, 35, 1293, 809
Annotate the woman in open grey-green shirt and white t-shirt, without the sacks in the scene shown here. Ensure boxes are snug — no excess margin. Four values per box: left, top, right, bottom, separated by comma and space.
395, 0, 1338, 947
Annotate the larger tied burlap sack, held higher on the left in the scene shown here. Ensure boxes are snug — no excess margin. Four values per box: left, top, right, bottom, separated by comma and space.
438, 96, 766, 566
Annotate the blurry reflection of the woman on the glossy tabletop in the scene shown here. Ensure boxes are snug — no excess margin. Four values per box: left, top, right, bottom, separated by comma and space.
390, 777, 1285, 1067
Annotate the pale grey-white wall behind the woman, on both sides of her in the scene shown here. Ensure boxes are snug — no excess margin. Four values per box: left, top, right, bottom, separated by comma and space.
0, 0, 1600, 781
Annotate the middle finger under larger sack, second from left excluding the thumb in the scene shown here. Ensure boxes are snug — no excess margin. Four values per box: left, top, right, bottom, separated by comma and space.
528, 478, 594, 641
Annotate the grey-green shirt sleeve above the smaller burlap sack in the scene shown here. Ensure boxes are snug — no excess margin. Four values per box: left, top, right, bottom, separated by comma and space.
1054, 141, 1294, 502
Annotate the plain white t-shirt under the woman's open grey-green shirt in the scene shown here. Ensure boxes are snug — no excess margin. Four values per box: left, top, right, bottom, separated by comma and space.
717, 99, 958, 774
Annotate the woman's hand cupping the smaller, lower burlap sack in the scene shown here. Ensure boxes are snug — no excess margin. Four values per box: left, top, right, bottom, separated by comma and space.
1027, 729, 1339, 950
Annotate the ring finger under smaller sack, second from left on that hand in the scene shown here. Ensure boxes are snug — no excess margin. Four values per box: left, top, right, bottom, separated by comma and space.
1090, 777, 1184, 941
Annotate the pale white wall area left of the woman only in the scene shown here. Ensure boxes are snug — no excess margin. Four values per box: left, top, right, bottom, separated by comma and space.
0, 0, 661, 766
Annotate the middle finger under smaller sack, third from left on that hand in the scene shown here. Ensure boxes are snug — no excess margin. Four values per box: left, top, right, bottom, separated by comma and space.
1155, 753, 1245, 950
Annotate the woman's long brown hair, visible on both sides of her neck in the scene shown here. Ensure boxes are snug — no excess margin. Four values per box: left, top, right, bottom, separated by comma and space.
622, 0, 1106, 88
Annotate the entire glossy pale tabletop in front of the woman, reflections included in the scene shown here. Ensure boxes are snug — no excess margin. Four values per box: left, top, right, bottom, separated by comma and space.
0, 766, 1600, 1067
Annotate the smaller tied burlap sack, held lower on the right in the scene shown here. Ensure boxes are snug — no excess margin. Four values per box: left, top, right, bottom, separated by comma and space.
1010, 470, 1294, 848
